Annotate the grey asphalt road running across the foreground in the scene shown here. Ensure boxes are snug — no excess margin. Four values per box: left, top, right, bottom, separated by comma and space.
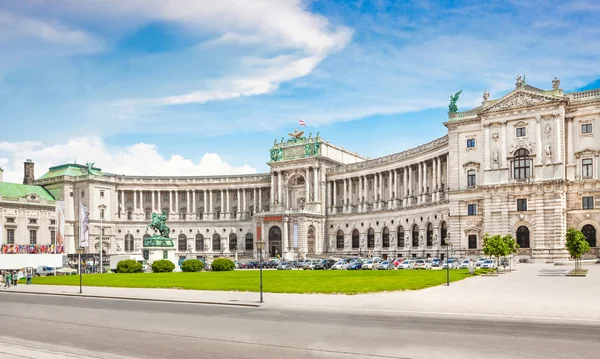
0, 290, 600, 359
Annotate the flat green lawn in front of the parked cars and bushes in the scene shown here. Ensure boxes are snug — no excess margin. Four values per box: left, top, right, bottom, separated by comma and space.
33, 270, 486, 294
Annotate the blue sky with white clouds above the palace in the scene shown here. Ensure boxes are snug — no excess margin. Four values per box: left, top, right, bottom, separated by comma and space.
0, 0, 600, 181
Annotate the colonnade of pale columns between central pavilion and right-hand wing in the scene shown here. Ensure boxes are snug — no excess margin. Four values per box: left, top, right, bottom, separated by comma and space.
327, 156, 448, 213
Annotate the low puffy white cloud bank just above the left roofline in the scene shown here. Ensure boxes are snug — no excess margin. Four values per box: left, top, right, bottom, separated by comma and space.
0, 137, 256, 183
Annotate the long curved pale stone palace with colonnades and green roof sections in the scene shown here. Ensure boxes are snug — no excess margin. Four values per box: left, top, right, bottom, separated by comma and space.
0, 77, 600, 261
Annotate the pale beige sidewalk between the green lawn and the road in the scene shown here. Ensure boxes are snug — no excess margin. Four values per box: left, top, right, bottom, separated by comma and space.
0, 264, 600, 325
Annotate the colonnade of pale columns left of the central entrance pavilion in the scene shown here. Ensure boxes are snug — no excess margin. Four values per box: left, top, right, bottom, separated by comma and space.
118, 187, 263, 219
